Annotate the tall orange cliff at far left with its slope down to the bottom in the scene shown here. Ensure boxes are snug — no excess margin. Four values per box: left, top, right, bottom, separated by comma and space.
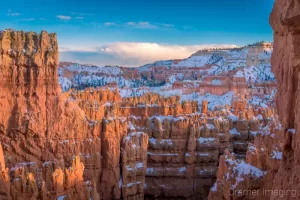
0, 30, 96, 200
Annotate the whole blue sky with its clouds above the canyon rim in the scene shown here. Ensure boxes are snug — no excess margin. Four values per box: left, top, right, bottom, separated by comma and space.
0, 0, 274, 65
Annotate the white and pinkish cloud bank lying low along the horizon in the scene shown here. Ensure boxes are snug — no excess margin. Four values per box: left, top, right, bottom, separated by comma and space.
59, 42, 237, 67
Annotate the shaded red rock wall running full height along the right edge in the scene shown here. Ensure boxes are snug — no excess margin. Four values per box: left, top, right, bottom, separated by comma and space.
270, 0, 300, 199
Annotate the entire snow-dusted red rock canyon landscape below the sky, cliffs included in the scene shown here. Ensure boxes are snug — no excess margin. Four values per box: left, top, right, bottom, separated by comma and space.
0, 0, 300, 200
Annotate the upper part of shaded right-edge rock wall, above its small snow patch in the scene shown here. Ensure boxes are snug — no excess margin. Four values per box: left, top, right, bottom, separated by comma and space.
270, 0, 300, 128
